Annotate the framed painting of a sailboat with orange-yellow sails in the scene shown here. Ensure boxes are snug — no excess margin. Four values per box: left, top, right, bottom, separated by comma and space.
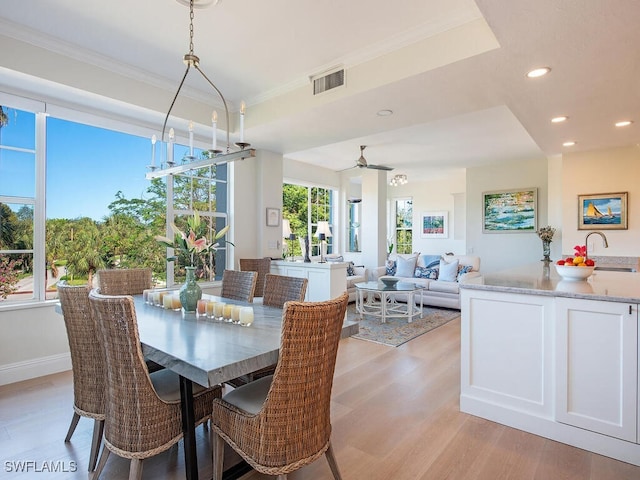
578, 192, 628, 230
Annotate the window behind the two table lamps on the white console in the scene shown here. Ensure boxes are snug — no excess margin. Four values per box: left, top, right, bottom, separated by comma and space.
282, 183, 336, 256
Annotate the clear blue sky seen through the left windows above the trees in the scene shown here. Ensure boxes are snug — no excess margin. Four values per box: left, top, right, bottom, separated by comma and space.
0, 107, 194, 220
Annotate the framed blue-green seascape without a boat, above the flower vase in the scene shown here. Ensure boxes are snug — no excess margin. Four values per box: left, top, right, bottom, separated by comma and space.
482, 188, 538, 233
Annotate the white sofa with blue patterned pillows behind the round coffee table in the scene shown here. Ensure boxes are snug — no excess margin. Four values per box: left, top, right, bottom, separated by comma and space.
371, 253, 480, 310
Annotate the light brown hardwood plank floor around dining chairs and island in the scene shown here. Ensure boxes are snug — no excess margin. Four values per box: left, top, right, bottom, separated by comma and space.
0, 319, 640, 480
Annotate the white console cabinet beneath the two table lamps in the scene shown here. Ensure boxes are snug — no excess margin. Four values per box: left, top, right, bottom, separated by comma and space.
271, 260, 347, 302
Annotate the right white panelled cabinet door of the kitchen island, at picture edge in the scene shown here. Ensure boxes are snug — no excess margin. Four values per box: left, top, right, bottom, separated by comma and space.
556, 298, 638, 442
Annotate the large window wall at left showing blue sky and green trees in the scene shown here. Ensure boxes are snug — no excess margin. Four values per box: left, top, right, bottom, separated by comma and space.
0, 93, 228, 305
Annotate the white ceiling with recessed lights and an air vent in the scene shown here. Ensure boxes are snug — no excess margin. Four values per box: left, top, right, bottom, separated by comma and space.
0, 0, 640, 180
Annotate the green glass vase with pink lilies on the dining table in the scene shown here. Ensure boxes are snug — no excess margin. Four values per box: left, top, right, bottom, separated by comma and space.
156, 211, 233, 312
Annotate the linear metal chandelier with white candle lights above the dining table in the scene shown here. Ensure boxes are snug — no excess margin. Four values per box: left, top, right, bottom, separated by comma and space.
146, 0, 255, 179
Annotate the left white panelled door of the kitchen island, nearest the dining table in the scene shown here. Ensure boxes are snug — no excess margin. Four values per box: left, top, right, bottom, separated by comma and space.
461, 289, 554, 418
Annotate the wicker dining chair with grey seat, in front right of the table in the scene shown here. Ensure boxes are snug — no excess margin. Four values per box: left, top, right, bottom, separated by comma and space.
211, 292, 349, 480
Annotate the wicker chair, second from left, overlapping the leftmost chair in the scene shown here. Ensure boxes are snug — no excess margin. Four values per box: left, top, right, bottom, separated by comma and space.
89, 290, 221, 479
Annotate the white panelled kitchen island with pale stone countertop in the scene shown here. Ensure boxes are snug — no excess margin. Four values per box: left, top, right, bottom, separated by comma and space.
460, 262, 640, 465
